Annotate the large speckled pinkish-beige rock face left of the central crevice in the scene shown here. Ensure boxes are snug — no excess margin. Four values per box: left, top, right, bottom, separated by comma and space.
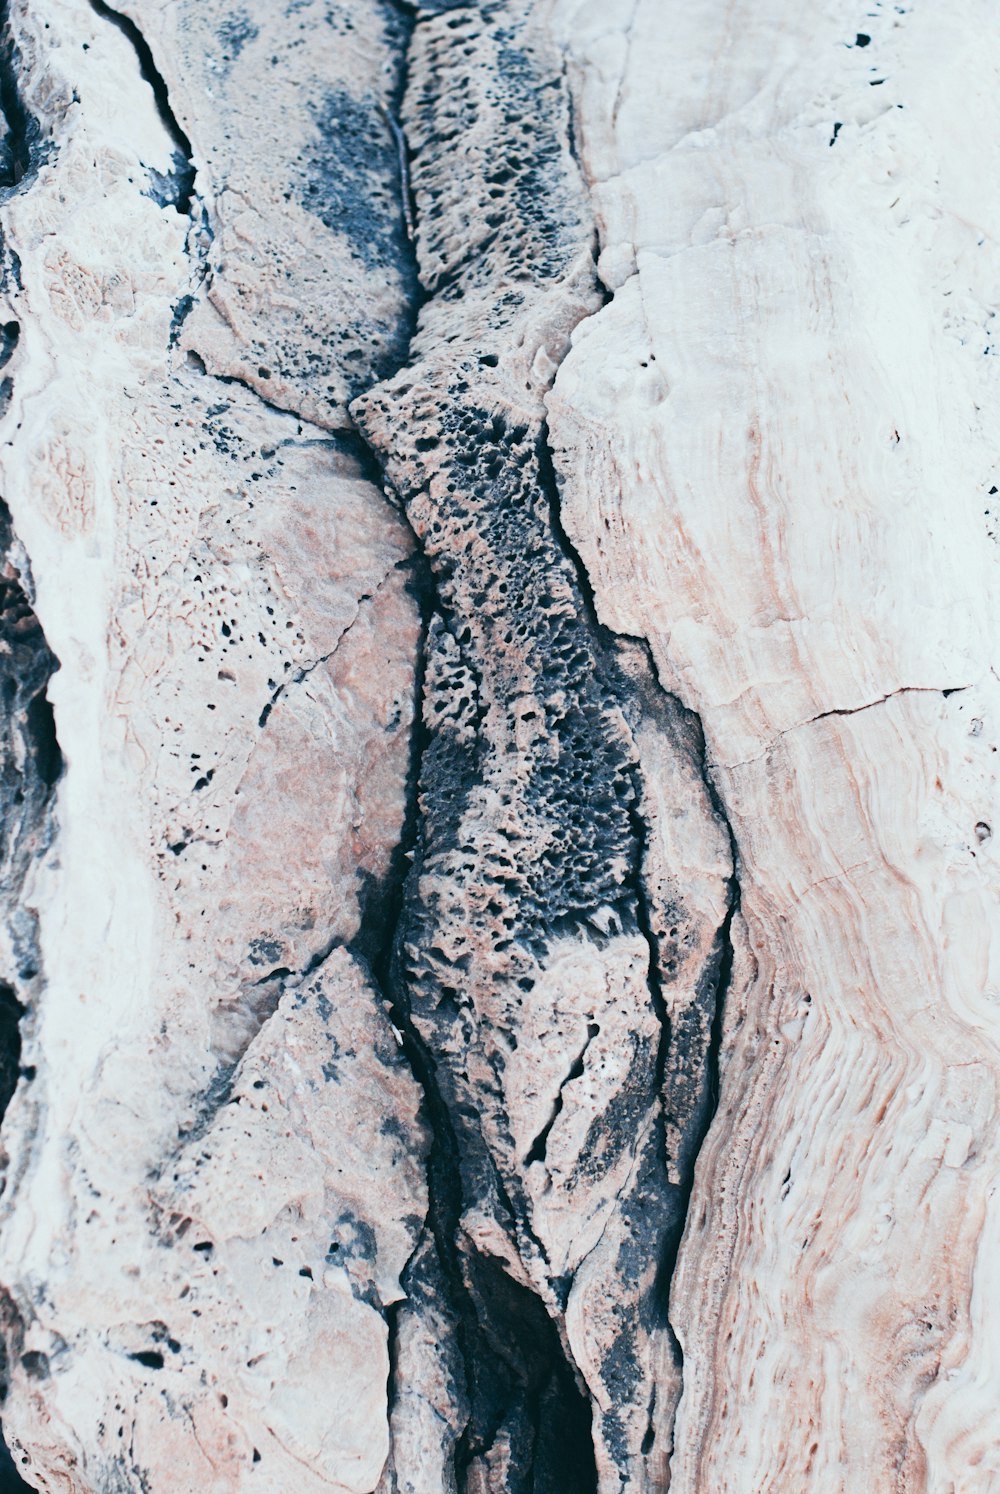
1, 0, 426, 1491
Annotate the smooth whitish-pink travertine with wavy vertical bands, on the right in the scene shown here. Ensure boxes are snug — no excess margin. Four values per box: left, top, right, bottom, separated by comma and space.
549, 0, 1000, 1494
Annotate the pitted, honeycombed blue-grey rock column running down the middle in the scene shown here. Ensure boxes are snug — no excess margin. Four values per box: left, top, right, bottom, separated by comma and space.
351, 3, 731, 1491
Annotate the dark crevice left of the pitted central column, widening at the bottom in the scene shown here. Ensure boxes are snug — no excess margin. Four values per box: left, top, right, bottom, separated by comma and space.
339, 6, 596, 1494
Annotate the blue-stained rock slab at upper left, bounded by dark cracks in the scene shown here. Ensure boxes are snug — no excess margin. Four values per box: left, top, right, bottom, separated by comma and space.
115, 0, 414, 429
